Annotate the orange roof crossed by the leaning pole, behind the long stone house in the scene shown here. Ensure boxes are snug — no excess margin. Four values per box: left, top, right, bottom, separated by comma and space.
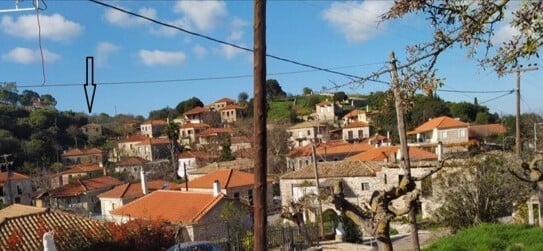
347, 146, 437, 161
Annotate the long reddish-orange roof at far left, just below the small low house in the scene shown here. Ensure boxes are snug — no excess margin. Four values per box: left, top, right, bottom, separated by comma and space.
50, 176, 122, 197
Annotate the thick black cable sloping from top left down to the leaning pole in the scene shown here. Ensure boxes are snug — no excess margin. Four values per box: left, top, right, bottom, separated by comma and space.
89, 0, 388, 83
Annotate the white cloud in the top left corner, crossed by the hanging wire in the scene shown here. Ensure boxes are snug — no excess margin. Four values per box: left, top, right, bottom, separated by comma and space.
0, 14, 83, 41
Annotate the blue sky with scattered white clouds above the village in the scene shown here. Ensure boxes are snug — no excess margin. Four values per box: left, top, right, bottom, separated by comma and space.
0, 0, 543, 116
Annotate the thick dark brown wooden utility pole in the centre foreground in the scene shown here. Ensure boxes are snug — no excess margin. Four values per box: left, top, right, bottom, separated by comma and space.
253, 0, 268, 250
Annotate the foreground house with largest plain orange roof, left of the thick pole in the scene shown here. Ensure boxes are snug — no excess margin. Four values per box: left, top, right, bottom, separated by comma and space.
111, 190, 250, 241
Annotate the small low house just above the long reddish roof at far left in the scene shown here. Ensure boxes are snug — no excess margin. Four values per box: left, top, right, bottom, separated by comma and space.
50, 163, 105, 188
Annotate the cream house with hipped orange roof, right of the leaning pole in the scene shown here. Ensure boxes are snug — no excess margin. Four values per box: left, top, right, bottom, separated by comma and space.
408, 116, 469, 149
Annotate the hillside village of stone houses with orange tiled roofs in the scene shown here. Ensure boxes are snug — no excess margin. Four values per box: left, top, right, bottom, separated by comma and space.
0, 84, 536, 249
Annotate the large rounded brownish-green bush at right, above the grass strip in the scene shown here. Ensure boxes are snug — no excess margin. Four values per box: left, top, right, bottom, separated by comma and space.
433, 154, 532, 230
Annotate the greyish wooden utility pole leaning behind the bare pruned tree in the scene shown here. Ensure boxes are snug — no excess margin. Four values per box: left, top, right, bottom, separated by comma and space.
390, 52, 420, 251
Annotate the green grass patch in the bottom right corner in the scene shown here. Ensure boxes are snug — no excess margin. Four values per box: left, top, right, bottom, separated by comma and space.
424, 224, 543, 251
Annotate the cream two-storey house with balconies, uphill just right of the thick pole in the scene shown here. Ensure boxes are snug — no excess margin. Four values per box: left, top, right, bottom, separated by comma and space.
287, 121, 328, 147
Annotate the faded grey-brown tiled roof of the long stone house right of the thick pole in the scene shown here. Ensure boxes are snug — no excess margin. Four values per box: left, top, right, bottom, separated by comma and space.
281, 160, 375, 179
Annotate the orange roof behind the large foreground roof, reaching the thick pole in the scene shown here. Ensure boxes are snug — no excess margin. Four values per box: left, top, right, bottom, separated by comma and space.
184, 169, 272, 189
